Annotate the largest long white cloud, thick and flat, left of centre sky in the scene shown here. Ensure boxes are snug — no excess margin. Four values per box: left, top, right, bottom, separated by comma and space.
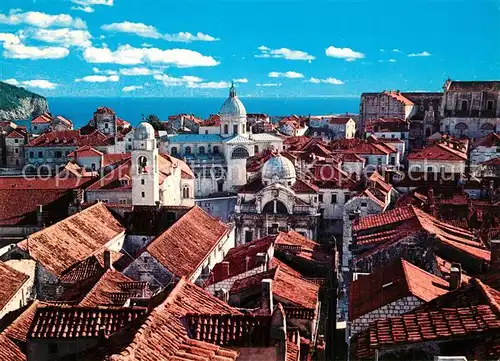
83, 45, 219, 68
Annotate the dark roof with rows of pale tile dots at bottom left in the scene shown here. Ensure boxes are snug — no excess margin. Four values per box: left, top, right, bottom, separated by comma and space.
28, 306, 146, 339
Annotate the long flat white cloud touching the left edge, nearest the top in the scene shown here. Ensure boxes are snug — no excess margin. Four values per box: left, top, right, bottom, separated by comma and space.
0, 11, 87, 29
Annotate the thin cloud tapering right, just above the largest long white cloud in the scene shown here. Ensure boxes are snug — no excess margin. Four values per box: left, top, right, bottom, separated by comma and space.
101, 21, 219, 43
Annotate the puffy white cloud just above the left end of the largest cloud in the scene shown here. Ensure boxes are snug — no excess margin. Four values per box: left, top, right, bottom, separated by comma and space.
28, 28, 92, 48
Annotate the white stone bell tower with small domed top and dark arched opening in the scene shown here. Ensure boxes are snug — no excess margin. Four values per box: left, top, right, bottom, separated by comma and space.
131, 122, 160, 206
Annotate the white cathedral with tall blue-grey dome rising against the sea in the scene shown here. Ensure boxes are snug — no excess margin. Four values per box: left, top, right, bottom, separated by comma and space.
160, 84, 283, 215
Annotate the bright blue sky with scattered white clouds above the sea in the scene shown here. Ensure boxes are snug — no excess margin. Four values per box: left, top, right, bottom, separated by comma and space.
0, 0, 500, 97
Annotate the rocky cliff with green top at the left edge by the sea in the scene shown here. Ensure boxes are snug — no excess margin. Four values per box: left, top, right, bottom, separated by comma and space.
0, 82, 49, 121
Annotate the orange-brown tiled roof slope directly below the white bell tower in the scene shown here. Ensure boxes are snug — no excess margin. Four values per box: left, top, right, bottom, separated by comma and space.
146, 206, 229, 278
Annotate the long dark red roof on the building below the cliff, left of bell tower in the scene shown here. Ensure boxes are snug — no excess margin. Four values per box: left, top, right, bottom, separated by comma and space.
25, 130, 114, 148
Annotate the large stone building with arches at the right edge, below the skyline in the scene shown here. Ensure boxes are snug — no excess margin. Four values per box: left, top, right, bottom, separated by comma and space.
440, 79, 500, 138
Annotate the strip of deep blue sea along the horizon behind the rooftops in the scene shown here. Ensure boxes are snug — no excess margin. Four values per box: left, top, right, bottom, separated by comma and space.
48, 97, 359, 127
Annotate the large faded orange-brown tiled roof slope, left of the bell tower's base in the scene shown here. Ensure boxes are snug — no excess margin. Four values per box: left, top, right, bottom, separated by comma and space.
17, 203, 124, 276
